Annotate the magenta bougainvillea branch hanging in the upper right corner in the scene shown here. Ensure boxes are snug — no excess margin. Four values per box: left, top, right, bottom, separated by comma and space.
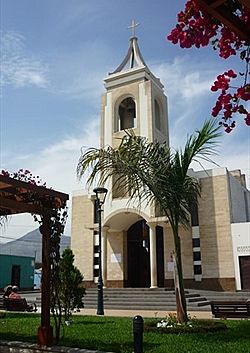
167, 0, 250, 132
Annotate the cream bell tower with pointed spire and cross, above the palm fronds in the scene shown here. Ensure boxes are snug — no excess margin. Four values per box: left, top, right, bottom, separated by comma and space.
100, 21, 169, 152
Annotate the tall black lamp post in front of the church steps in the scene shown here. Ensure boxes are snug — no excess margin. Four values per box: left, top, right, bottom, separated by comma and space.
93, 187, 108, 315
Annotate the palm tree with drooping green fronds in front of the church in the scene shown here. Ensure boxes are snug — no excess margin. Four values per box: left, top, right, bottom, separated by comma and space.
77, 120, 220, 322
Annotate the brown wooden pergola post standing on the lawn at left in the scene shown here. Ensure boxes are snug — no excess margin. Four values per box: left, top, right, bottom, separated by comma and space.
37, 215, 53, 346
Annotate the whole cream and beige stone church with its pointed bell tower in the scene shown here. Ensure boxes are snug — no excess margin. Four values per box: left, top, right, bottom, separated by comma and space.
71, 25, 250, 291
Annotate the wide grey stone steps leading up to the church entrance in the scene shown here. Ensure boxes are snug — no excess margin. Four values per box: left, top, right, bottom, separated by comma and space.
33, 288, 250, 312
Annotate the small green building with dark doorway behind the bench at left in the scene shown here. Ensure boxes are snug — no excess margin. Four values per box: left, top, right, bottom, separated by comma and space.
0, 255, 35, 289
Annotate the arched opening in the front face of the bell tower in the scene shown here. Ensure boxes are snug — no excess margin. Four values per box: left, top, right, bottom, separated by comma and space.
118, 97, 136, 130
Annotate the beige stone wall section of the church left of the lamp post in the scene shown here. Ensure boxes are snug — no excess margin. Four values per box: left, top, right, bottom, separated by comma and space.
71, 195, 94, 281
